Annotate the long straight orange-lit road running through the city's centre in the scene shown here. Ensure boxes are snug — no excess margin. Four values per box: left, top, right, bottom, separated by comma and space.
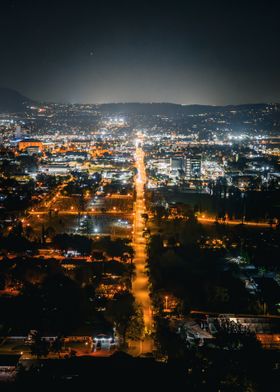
132, 142, 153, 354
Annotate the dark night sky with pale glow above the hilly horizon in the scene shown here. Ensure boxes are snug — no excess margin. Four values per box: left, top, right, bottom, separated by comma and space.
0, 0, 280, 104
